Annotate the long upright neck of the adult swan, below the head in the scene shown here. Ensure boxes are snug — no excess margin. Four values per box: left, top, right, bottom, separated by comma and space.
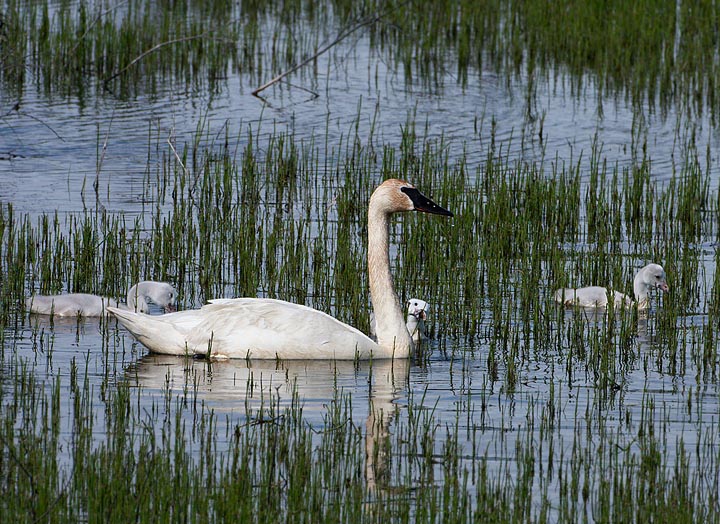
368, 203, 414, 358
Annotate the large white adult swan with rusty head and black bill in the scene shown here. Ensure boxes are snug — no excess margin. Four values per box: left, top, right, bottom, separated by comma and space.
108, 179, 452, 360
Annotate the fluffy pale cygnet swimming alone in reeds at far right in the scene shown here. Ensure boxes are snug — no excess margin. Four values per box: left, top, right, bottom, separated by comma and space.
555, 264, 670, 309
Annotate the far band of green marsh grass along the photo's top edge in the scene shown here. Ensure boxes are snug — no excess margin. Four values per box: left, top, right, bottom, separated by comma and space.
0, 0, 720, 121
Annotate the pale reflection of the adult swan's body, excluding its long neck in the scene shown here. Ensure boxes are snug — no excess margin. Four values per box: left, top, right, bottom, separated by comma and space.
126, 354, 410, 414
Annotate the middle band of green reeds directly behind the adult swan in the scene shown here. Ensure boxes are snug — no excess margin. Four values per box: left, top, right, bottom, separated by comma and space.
0, 113, 717, 380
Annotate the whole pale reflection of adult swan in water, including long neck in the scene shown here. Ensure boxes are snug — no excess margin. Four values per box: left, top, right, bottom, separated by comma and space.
126, 354, 410, 494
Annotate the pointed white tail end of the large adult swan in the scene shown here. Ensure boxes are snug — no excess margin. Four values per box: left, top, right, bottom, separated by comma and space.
107, 307, 193, 355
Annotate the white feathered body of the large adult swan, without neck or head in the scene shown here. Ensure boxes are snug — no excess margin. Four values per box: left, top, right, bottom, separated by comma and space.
110, 298, 382, 360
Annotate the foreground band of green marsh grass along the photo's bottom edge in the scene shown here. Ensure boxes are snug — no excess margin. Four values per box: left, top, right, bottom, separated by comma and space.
0, 348, 720, 522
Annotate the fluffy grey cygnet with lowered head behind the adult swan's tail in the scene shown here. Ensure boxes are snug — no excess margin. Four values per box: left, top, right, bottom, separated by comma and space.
25, 280, 177, 317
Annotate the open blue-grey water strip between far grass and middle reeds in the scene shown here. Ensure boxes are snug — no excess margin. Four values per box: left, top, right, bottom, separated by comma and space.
5, 33, 720, 214
